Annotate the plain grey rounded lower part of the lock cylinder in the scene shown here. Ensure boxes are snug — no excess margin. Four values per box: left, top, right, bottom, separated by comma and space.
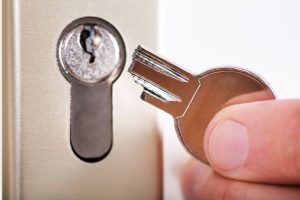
70, 82, 113, 162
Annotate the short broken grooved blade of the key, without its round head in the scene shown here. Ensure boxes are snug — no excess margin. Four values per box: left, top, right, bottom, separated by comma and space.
128, 46, 200, 117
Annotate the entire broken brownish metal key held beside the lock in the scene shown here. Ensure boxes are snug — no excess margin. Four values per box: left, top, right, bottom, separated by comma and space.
129, 46, 275, 164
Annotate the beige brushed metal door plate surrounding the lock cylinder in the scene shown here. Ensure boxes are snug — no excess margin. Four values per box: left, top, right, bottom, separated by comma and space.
2, 0, 162, 200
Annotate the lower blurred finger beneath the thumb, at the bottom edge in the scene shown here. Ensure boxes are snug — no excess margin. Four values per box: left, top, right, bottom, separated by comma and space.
182, 161, 300, 200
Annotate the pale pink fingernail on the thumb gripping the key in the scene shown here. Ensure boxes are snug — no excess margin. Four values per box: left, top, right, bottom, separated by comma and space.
208, 120, 249, 171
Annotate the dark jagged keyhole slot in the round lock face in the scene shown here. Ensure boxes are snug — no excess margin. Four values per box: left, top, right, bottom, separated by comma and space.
80, 26, 101, 63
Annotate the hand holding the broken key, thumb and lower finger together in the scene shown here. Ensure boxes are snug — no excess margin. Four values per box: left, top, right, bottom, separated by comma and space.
182, 100, 300, 200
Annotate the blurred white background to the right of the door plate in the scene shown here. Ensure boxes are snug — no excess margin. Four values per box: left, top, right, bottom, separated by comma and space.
158, 0, 300, 200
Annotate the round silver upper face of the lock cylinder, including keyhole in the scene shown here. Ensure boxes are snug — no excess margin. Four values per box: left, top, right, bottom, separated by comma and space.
58, 17, 126, 83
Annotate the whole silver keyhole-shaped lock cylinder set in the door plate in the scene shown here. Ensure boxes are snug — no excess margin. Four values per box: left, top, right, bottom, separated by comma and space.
57, 17, 126, 162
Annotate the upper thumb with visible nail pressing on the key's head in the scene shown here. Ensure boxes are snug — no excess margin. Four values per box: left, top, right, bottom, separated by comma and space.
204, 100, 300, 184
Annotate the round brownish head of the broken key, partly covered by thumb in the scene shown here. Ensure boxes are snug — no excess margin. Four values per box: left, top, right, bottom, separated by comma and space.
175, 68, 276, 164
